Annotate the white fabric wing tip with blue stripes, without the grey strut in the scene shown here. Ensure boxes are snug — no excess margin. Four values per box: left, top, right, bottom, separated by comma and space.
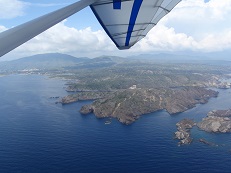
91, 0, 181, 49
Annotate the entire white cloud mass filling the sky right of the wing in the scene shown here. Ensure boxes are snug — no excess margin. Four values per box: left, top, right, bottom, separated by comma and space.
131, 0, 231, 52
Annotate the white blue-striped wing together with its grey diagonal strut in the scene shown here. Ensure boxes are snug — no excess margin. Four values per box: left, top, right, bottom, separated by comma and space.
0, 0, 181, 57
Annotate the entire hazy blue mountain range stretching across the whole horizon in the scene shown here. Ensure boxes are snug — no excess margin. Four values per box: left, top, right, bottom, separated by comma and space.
0, 52, 231, 71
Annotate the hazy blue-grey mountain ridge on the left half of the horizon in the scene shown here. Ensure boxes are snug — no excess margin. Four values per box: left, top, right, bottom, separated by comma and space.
0, 53, 130, 71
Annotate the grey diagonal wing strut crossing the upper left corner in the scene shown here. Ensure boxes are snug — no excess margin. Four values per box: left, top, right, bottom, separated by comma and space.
0, 0, 97, 57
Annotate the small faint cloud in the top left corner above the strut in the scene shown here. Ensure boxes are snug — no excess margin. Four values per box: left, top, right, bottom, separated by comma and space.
0, 0, 27, 19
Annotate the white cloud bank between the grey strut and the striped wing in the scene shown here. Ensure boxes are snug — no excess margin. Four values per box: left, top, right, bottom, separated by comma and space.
13, 21, 115, 55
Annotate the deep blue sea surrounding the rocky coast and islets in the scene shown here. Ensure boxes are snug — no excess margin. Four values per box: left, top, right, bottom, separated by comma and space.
0, 75, 231, 173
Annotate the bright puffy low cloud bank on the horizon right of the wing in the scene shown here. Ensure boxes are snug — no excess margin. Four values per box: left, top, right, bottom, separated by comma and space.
130, 25, 231, 52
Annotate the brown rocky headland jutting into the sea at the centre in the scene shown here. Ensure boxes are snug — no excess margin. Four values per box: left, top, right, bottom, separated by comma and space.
80, 87, 218, 124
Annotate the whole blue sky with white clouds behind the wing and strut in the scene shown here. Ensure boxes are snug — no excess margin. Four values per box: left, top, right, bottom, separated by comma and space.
0, 0, 231, 61
